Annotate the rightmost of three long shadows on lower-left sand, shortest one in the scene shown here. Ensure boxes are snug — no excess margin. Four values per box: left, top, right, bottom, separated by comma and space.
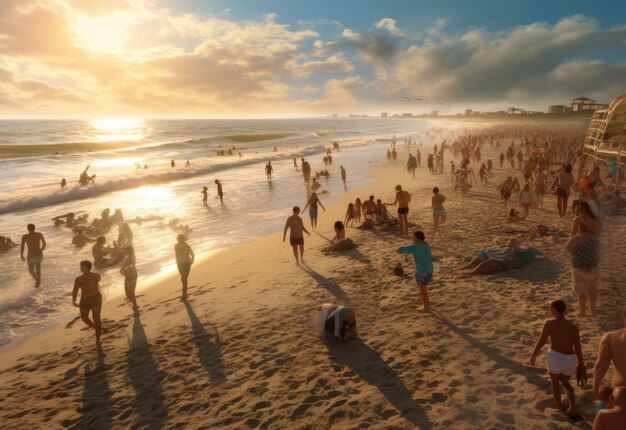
183, 300, 226, 384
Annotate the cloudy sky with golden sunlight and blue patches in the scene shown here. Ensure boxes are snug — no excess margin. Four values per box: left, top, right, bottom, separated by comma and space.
0, 0, 626, 118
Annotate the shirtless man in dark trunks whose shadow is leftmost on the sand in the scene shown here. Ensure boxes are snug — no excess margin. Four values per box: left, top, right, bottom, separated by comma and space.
72, 260, 102, 343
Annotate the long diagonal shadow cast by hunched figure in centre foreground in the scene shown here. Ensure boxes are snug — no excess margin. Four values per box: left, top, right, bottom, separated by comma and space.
326, 339, 432, 429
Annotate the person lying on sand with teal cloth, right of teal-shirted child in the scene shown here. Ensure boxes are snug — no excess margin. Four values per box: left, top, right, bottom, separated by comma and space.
457, 239, 543, 276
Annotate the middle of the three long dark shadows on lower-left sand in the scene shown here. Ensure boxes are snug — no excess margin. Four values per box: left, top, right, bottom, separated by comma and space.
127, 316, 167, 429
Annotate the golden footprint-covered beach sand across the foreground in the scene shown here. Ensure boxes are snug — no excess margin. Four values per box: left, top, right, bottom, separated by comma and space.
0, 139, 626, 429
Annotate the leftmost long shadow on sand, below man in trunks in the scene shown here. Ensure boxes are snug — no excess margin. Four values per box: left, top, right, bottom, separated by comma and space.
78, 346, 114, 429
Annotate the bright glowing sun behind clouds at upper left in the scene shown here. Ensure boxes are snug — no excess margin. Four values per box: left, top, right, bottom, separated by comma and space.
72, 14, 128, 53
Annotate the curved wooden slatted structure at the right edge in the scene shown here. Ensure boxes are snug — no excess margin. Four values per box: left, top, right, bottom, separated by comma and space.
578, 94, 626, 187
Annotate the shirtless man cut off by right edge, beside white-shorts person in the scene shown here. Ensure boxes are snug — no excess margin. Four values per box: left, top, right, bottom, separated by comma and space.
593, 306, 626, 398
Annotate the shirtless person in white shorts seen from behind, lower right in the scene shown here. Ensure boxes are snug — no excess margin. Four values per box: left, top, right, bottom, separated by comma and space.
530, 300, 584, 414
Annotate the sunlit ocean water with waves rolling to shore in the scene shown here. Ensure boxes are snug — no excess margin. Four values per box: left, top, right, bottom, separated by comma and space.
0, 119, 429, 345
